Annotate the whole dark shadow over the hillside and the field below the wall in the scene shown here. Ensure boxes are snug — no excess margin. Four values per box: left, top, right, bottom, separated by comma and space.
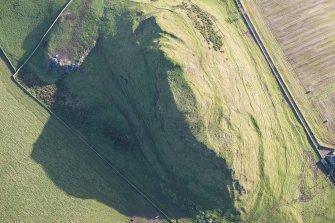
25, 7, 241, 221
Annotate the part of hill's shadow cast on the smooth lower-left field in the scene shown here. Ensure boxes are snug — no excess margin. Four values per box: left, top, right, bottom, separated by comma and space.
31, 118, 158, 221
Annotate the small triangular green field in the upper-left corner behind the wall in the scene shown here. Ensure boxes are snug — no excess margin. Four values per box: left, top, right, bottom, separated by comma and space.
0, 0, 67, 66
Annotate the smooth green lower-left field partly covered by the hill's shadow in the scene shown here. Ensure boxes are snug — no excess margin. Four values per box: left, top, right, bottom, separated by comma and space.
0, 36, 163, 222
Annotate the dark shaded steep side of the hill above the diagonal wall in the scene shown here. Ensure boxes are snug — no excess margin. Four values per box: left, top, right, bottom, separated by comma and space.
21, 3, 238, 218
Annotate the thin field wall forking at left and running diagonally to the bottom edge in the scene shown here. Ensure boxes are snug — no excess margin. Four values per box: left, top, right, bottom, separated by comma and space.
0, 0, 178, 223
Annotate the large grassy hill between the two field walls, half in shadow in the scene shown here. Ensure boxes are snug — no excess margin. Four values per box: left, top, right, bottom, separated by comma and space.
1, 0, 335, 222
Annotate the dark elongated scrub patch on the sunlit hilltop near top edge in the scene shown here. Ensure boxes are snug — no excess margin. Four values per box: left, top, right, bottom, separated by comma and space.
180, 2, 223, 51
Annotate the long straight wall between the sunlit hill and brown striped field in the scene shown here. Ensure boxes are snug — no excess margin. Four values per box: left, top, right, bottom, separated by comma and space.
234, 0, 334, 157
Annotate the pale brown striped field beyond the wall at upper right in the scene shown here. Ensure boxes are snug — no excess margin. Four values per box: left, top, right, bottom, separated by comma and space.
243, 0, 335, 147
